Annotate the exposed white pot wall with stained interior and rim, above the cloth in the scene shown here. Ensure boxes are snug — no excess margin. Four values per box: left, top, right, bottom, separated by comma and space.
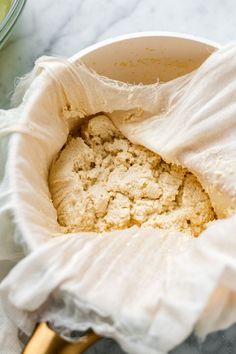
71, 32, 219, 84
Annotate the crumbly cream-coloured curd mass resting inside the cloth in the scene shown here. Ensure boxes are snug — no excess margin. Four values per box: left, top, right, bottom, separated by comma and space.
49, 115, 215, 236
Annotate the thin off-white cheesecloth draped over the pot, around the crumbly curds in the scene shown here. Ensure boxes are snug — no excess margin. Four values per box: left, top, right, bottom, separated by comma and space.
0, 45, 236, 354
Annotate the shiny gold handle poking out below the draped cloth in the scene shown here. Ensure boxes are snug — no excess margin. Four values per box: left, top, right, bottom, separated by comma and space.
22, 323, 101, 354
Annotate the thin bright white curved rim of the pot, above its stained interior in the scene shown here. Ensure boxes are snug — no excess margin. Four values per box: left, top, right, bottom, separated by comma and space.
70, 31, 221, 61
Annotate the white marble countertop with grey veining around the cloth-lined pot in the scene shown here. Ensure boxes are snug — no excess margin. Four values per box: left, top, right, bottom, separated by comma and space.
0, 0, 236, 354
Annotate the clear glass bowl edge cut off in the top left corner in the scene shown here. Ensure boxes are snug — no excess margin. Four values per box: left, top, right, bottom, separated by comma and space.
0, 0, 26, 48
